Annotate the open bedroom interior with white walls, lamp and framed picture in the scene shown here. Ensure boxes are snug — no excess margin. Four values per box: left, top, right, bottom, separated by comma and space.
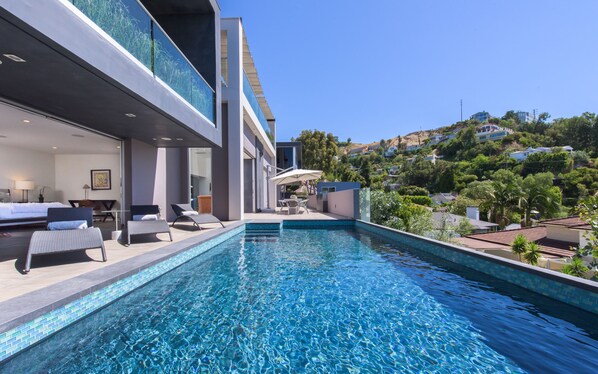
0, 102, 121, 225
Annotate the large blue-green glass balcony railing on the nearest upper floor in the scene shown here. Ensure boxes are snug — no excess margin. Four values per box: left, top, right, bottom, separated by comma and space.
69, 0, 216, 123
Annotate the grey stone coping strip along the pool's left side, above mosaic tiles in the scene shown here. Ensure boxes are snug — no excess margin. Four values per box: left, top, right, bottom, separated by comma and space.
0, 221, 246, 334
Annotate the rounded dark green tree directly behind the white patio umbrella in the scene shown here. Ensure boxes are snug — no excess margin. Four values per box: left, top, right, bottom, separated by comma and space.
297, 130, 338, 174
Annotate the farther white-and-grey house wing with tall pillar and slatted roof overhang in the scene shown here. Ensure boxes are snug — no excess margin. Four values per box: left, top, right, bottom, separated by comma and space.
212, 18, 276, 220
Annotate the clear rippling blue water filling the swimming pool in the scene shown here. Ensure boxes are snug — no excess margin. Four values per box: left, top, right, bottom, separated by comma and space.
0, 229, 598, 373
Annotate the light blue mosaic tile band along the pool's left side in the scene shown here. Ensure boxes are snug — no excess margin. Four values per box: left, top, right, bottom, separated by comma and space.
0, 225, 245, 362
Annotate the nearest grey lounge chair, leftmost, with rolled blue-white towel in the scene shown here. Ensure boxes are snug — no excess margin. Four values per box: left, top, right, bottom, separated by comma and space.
23, 208, 107, 273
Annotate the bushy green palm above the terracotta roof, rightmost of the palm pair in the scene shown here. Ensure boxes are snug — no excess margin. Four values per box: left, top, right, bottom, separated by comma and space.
519, 173, 561, 227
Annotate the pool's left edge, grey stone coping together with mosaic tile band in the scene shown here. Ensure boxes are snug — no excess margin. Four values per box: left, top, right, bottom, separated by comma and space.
0, 221, 245, 362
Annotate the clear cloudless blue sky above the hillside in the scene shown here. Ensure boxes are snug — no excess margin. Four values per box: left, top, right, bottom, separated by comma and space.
219, 0, 598, 142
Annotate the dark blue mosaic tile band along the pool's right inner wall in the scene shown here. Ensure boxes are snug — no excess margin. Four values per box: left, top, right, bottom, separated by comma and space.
356, 222, 598, 314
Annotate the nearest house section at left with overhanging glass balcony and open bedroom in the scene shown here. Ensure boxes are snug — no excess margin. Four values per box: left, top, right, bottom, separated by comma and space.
0, 0, 227, 218
